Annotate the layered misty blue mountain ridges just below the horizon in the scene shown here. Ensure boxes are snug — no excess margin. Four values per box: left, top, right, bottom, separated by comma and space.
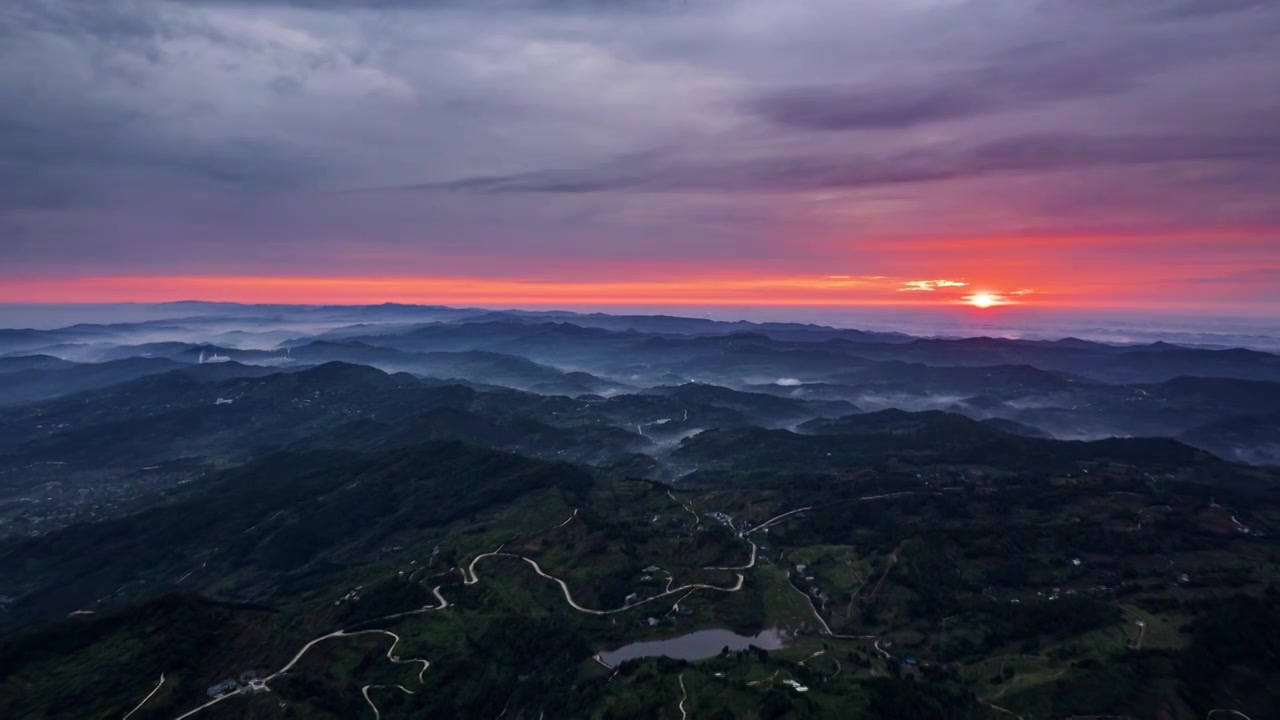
0, 304, 1280, 471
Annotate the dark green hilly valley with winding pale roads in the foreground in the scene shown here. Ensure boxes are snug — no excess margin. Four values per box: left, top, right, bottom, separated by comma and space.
0, 303, 1280, 720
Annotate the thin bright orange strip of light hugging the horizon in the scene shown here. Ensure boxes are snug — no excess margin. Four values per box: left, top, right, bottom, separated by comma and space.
0, 266, 1259, 310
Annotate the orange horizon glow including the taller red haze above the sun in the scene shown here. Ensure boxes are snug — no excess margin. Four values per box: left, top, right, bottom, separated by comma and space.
0, 228, 1280, 311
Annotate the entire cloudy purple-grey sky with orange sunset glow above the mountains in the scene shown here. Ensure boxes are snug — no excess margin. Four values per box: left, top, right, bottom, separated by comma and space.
0, 0, 1280, 312
